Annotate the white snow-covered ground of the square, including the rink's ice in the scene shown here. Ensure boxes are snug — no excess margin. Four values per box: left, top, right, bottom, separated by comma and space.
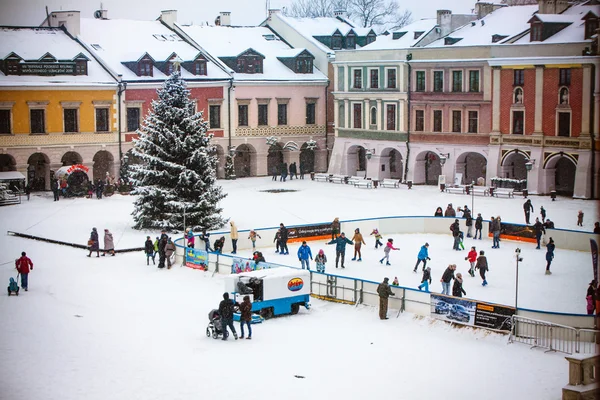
0, 178, 598, 400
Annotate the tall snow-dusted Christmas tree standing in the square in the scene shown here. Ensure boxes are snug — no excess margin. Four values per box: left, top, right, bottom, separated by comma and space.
130, 72, 226, 231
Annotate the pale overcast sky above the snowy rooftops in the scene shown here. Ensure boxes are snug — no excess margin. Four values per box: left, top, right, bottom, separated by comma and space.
0, 0, 476, 26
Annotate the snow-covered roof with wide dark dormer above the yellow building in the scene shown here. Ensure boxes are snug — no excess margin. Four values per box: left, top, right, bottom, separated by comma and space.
0, 26, 116, 87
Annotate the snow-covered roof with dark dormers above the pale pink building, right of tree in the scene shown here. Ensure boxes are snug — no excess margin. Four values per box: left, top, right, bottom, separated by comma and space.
179, 25, 327, 81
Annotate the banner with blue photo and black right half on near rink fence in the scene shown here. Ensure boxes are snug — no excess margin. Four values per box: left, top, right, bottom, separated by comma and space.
431, 294, 515, 331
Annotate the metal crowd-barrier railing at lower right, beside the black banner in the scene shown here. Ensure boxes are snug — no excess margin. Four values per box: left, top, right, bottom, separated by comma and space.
508, 315, 600, 354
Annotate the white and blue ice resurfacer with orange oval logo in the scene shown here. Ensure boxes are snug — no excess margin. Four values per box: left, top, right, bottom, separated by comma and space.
225, 267, 310, 319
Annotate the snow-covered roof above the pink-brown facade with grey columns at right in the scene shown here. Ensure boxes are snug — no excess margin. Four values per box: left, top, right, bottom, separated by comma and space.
425, 5, 538, 47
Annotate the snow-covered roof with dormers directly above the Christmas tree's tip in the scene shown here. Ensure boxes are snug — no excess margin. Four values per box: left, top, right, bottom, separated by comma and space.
79, 18, 229, 81
